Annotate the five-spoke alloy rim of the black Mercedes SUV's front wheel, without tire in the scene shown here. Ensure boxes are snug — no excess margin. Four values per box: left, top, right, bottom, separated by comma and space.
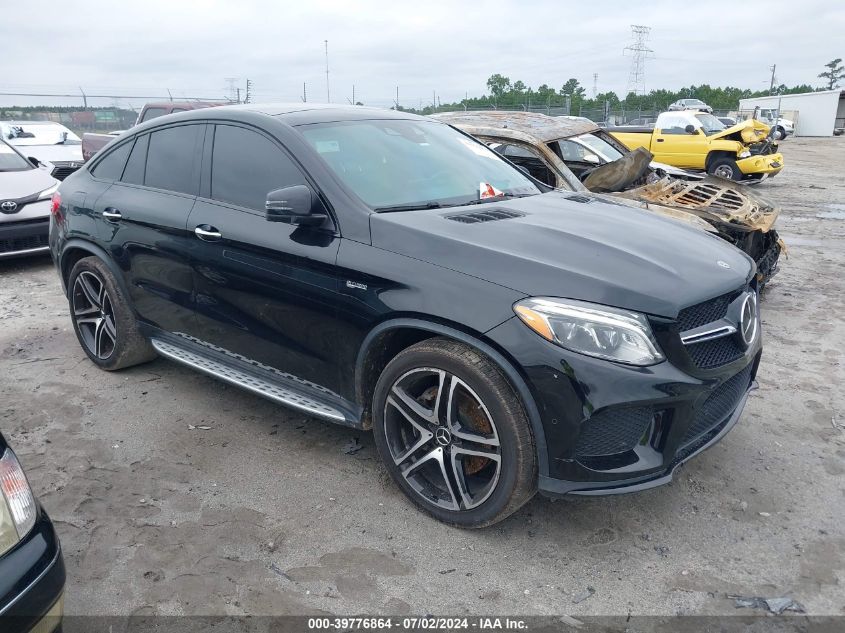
384, 368, 502, 511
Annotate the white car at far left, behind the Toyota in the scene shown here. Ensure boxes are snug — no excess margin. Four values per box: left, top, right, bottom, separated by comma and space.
0, 121, 83, 180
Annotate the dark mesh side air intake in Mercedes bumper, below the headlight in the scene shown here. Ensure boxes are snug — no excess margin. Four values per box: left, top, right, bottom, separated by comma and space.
575, 407, 654, 457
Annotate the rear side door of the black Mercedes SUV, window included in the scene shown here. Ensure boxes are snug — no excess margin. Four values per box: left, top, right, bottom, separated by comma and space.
93, 124, 205, 332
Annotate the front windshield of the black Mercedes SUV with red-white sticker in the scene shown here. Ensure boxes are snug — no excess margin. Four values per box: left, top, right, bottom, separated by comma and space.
299, 119, 541, 210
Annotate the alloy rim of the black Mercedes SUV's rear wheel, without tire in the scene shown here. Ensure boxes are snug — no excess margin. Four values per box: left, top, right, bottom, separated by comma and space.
72, 270, 117, 360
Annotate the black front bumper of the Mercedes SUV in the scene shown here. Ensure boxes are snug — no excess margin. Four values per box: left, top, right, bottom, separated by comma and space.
487, 319, 761, 496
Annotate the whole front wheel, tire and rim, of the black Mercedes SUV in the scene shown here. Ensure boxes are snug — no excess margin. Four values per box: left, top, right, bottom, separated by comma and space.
373, 338, 537, 528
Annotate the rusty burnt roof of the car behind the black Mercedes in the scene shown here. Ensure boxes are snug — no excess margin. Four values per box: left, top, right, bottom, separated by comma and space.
431, 110, 601, 143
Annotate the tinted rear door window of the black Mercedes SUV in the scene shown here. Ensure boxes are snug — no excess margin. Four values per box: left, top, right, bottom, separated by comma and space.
144, 125, 204, 195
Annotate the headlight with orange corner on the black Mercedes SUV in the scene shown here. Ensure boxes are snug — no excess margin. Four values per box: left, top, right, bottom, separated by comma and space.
513, 297, 664, 367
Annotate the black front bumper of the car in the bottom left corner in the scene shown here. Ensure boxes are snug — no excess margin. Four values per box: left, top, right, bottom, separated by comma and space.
0, 509, 65, 633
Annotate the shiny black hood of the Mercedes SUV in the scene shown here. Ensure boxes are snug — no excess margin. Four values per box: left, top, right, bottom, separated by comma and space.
370, 192, 754, 318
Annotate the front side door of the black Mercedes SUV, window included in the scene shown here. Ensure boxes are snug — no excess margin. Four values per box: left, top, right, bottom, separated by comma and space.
188, 123, 340, 390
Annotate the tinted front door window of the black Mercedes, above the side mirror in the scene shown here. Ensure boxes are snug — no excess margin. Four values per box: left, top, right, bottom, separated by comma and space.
211, 125, 305, 212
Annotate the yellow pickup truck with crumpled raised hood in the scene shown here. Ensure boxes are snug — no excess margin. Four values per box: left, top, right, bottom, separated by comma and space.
607, 110, 783, 180
